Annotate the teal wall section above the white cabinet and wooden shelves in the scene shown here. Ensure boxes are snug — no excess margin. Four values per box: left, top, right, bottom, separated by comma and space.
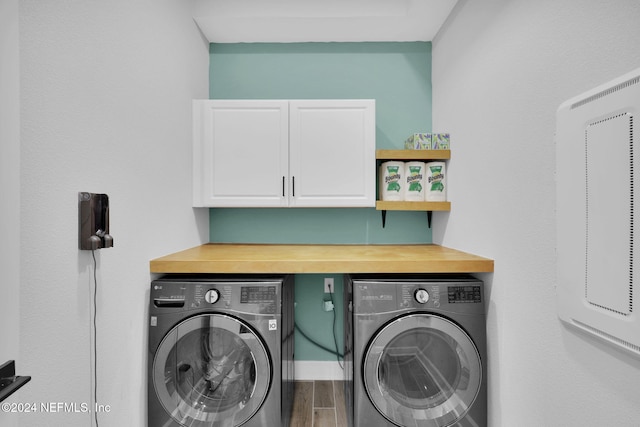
209, 42, 431, 148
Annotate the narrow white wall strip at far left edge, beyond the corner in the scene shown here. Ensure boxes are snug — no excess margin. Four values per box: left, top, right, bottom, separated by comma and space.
0, 0, 20, 427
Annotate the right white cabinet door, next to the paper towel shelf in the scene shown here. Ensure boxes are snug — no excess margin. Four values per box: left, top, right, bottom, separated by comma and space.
289, 100, 376, 207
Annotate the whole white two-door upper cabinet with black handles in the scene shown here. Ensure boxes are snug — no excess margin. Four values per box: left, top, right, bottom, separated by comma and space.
193, 100, 376, 207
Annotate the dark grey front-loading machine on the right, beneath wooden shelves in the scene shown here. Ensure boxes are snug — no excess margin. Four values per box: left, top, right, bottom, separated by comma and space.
345, 275, 487, 427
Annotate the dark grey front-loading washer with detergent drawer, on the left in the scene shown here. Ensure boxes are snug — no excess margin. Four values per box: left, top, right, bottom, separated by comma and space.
148, 275, 294, 427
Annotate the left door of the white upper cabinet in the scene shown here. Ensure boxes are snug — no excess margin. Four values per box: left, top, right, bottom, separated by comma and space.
193, 100, 289, 207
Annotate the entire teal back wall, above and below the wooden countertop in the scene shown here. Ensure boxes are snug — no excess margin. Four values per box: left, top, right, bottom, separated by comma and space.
209, 42, 431, 360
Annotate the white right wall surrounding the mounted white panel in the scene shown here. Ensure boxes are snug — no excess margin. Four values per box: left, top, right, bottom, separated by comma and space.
433, 0, 640, 427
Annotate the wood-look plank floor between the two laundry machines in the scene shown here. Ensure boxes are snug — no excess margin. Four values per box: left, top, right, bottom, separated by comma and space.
291, 381, 347, 427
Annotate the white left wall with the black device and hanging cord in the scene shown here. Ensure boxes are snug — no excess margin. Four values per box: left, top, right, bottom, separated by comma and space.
20, 0, 209, 427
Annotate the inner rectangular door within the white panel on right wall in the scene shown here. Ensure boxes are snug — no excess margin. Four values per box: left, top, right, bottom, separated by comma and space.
585, 112, 633, 315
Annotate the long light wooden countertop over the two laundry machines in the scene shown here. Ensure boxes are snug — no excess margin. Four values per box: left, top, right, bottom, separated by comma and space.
150, 243, 493, 274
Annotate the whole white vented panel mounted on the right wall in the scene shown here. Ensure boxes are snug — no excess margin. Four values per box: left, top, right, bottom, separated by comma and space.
556, 69, 640, 356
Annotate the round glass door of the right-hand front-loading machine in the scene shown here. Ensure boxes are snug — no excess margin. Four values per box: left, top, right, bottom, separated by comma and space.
363, 314, 482, 427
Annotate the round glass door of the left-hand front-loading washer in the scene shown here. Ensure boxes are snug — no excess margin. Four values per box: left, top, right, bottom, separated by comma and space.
153, 314, 271, 427
